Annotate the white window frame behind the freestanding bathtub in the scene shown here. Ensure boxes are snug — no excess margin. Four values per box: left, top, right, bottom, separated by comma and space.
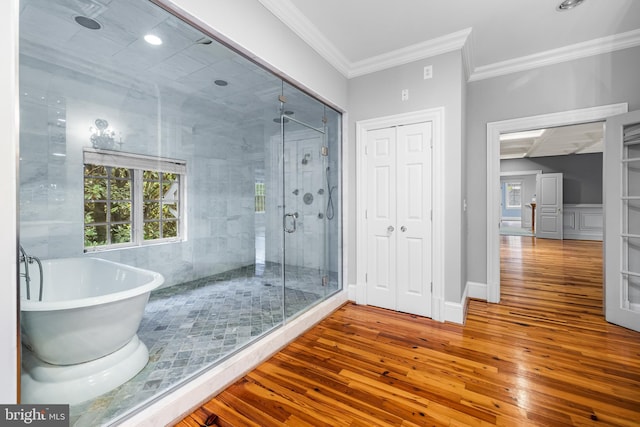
83, 148, 187, 252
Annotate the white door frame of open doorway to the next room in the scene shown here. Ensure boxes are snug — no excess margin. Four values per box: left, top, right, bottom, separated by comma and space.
488, 102, 628, 303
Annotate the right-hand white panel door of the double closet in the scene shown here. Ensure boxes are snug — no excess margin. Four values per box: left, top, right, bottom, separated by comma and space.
396, 122, 432, 317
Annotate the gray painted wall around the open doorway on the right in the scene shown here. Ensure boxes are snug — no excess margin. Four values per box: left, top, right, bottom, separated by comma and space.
465, 47, 640, 283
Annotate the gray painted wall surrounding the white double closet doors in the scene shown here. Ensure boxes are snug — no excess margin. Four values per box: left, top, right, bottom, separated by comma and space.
344, 51, 466, 302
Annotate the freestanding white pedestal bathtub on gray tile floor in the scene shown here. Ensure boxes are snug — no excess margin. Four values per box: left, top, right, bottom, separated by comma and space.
20, 258, 164, 405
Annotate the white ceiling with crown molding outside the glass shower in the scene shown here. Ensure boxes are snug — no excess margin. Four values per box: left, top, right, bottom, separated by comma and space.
259, 0, 640, 80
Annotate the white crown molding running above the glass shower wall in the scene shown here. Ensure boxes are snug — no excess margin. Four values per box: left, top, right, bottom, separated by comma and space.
258, 0, 351, 77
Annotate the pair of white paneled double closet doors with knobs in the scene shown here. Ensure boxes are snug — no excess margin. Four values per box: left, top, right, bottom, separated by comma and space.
366, 122, 432, 317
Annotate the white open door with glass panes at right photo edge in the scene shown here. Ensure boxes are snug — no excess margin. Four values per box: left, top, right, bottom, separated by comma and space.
604, 111, 640, 331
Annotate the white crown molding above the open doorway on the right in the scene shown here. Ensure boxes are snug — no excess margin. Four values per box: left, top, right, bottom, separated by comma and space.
469, 29, 640, 82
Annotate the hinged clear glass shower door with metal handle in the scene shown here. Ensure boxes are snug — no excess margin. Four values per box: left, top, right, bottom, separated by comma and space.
282, 114, 329, 318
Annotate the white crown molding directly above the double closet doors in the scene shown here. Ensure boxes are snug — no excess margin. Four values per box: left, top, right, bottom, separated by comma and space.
347, 28, 471, 78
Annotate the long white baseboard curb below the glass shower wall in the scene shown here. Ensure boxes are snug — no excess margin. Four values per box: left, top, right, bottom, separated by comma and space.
127, 292, 347, 427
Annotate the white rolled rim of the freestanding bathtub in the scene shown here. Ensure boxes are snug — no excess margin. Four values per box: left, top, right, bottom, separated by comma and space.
20, 257, 164, 312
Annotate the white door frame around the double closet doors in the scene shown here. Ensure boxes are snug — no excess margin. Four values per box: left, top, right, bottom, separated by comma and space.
356, 107, 445, 321
